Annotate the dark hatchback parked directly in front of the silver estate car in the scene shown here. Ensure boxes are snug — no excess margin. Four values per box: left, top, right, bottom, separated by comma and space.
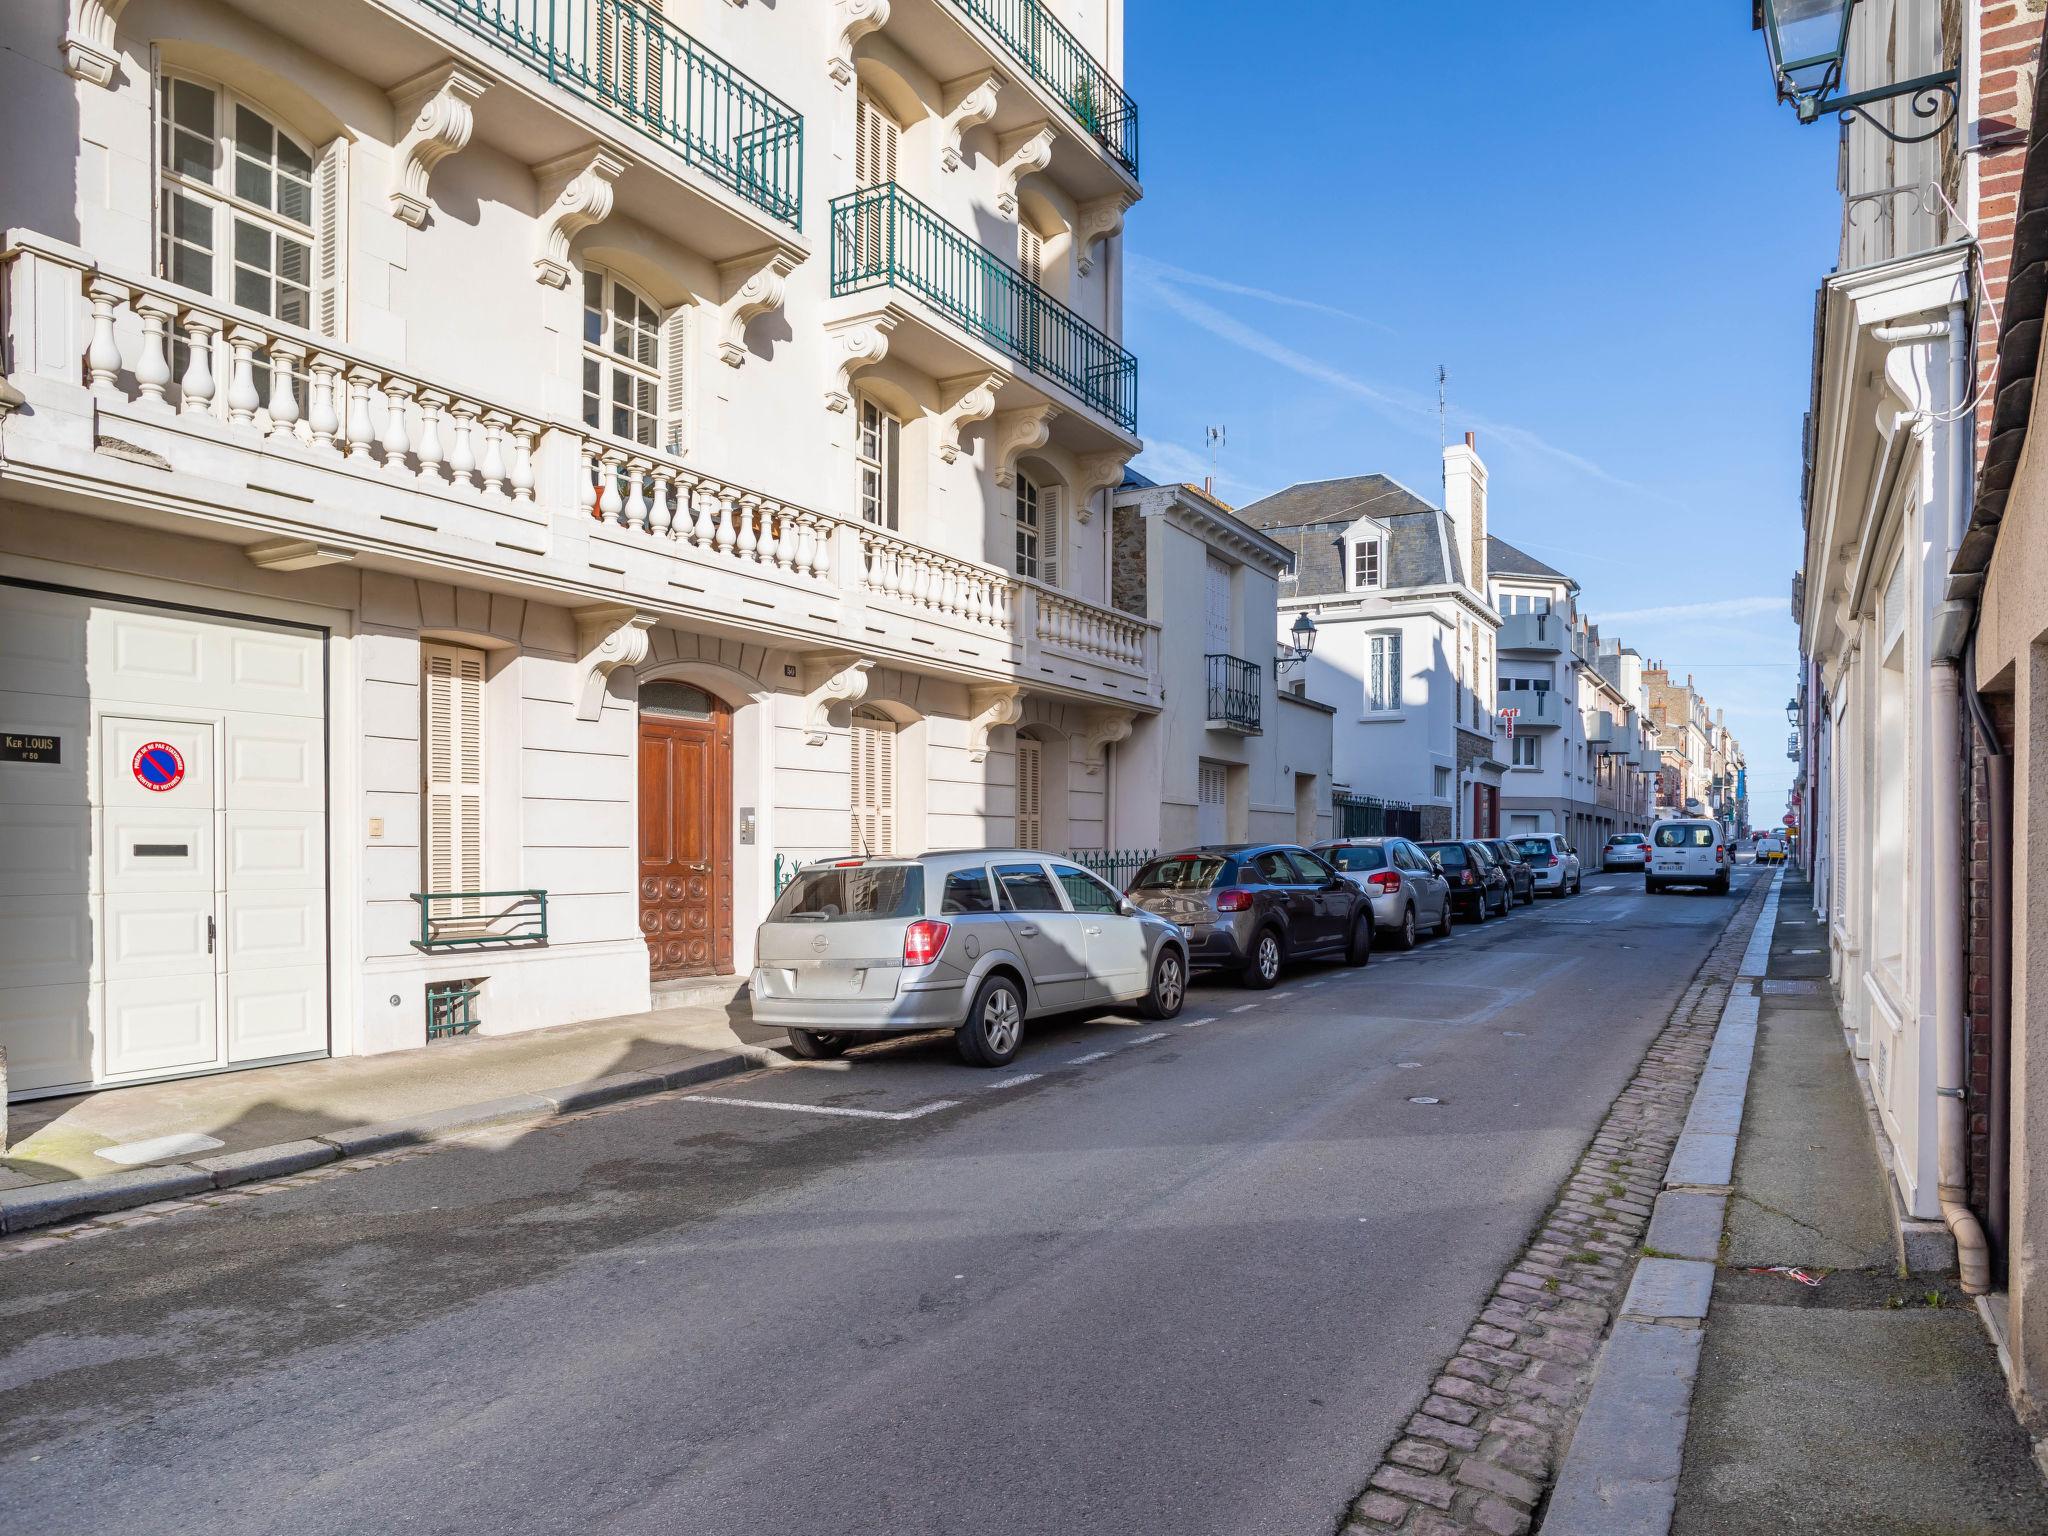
1126, 844, 1372, 987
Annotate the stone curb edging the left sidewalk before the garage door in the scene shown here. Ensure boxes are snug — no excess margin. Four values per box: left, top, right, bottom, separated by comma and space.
0, 1044, 788, 1237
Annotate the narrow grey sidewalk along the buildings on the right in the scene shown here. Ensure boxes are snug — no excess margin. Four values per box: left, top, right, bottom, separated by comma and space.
1651, 874, 2048, 1536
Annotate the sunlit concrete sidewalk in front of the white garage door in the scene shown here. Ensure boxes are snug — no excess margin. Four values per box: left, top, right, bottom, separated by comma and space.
0, 1001, 782, 1194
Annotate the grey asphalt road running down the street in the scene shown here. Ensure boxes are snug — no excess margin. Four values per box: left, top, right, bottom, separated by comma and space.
0, 870, 1755, 1536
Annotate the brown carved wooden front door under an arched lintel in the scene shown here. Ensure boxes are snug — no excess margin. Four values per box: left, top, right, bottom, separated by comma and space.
639, 682, 733, 981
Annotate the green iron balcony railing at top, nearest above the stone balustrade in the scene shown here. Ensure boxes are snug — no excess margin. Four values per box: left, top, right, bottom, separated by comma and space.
422, 0, 803, 229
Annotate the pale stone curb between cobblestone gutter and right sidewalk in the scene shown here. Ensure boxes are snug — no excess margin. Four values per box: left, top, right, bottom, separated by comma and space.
1542, 870, 1784, 1536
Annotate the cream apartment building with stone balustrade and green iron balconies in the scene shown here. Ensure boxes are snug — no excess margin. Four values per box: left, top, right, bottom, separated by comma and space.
0, 0, 1161, 1094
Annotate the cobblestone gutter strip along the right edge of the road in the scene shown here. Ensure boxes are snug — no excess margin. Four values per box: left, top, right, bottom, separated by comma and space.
1341, 881, 1772, 1536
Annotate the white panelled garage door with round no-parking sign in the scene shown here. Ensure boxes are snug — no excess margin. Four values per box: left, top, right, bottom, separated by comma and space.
0, 584, 328, 1096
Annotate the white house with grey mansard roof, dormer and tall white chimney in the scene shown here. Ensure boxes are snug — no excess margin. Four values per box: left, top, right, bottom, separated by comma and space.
1241, 434, 1507, 838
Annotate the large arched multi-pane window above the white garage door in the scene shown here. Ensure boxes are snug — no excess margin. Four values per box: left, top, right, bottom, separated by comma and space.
158, 74, 323, 336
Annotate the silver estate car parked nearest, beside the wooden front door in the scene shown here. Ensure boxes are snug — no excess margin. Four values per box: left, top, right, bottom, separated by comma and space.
752, 848, 1188, 1067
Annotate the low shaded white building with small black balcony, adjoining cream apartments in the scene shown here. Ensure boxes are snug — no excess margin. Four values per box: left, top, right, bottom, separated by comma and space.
1110, 473, 1335, 850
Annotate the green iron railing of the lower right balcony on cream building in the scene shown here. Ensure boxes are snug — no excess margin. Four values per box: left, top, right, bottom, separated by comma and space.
831, 182, 1139, 432
